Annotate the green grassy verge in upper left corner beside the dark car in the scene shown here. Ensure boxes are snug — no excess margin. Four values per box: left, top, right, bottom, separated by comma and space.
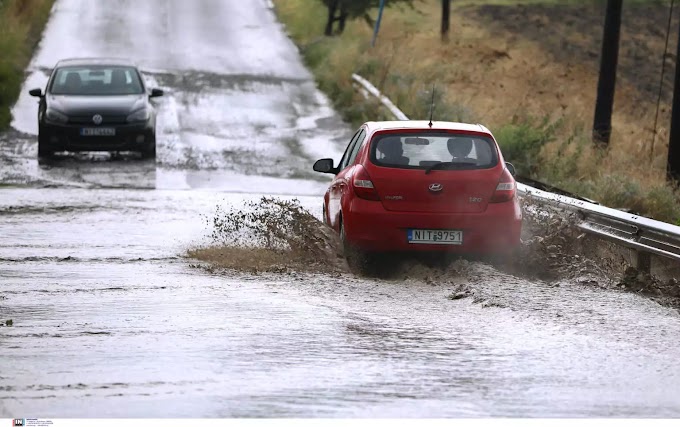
0, 0, 54, 129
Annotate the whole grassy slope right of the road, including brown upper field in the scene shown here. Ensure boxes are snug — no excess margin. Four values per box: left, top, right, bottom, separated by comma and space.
274, 0, 680, 222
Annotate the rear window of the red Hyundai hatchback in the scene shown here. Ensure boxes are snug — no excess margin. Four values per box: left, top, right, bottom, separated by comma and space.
371, 133, 498, 170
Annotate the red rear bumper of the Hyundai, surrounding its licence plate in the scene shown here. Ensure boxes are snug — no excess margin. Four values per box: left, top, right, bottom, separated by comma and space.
343, 197, 522, 254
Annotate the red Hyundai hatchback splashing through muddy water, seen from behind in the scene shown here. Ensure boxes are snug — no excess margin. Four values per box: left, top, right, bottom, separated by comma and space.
314, 121, 522, 270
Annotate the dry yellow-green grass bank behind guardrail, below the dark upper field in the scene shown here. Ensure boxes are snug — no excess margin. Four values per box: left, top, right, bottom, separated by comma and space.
274, 0, 680, 223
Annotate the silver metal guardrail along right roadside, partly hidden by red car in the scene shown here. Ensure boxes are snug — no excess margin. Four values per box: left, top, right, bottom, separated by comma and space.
352, 74, 680, 270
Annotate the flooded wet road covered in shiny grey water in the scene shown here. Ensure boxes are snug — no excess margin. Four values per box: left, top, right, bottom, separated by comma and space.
0, 0, 680, 418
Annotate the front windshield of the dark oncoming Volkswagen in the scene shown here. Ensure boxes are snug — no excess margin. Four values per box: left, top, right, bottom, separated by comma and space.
50, 66, 144, 95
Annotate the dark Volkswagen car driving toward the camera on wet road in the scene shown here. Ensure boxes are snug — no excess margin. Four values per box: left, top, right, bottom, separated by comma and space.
29, 58, 163, 158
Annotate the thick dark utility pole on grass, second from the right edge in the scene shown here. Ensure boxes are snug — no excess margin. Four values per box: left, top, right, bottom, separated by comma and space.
593, 0, 623, 144
